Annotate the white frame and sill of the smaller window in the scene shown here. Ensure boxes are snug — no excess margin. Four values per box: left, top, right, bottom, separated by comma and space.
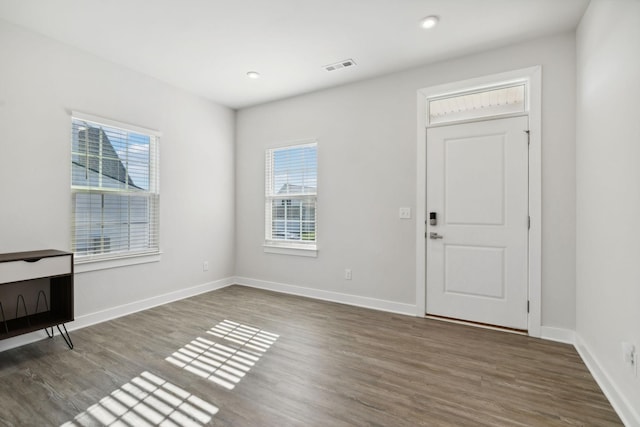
263, 139, 318, 257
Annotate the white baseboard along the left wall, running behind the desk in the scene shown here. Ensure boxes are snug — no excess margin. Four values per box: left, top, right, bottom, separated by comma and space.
0, 277, 234, 351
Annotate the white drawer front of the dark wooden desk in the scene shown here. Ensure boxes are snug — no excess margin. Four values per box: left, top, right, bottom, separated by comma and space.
0, 255, 71, 283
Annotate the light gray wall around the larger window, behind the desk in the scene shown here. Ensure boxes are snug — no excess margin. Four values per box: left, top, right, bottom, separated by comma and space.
0, 21, 235, 317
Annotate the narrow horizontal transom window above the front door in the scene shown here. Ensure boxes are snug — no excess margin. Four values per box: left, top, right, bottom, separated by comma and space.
428, 84, 525, 124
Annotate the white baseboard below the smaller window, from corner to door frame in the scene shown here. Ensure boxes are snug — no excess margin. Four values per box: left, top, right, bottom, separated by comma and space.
235, 277, 416, 317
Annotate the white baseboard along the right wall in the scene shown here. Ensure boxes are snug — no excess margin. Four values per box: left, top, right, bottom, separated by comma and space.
575, 334, 640, 427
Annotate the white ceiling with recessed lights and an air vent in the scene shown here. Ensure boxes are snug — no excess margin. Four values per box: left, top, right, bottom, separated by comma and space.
0, 0, 588, 108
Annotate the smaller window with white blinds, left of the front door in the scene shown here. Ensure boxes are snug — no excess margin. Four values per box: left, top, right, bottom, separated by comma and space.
265, 142, 318, 248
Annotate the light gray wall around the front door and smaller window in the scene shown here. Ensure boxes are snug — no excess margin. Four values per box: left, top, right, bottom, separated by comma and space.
236, 34, 575, 329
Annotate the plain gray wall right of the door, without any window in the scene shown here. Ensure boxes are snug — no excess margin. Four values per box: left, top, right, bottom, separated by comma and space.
576, 0, 640, 425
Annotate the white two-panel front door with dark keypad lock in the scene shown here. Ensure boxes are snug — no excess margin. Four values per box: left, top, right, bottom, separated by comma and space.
426, 117, 529, 330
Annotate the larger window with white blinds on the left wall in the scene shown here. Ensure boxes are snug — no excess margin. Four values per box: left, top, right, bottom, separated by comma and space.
71, 113, 160, 262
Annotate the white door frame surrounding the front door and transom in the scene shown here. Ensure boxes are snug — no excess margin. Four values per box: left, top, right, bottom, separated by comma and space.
416, 66, 542, 337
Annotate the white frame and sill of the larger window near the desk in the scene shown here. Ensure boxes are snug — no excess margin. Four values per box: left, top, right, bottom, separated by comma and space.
69, 111, 162, 273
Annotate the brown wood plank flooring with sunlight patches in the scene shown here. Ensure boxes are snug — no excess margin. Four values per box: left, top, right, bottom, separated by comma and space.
0, 286, 621, 427
